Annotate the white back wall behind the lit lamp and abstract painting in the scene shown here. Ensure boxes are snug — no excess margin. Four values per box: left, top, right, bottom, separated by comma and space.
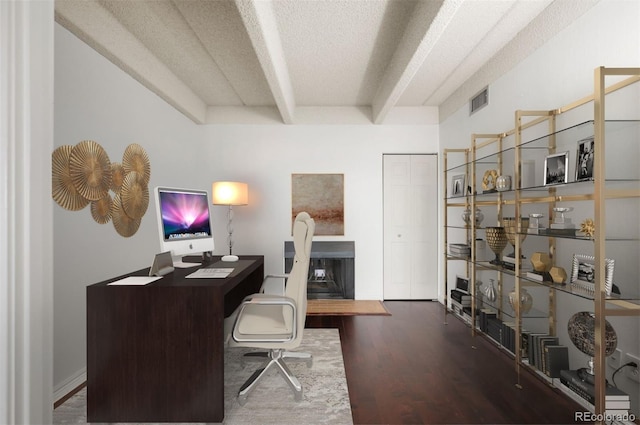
203, 125, 438, 299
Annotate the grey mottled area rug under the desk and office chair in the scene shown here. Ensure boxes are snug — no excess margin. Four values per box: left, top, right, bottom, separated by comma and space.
53, 329, 353, 425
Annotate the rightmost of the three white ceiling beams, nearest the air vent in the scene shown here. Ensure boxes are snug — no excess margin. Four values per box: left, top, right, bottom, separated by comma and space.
372, 0, 464, 124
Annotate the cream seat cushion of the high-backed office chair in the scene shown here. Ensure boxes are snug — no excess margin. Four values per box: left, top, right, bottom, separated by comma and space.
237, 305, 292, 335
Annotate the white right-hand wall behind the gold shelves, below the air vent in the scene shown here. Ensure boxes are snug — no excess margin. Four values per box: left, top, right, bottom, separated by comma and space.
440, 0, 640, 415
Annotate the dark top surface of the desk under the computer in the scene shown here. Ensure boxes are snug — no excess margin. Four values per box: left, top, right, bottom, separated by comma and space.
88, 255, 264, 288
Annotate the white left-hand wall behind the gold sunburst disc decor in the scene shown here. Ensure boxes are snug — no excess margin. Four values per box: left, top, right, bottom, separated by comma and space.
51, 24, 209, 398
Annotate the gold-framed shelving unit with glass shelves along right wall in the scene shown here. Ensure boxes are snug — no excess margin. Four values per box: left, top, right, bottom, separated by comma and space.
443, 67, 640, 414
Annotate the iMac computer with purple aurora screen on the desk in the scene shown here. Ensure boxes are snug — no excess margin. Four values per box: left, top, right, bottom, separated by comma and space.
155, 187, 214, 265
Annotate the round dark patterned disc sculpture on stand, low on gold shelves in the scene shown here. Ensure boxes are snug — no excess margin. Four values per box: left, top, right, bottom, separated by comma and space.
567, 311, 618, 384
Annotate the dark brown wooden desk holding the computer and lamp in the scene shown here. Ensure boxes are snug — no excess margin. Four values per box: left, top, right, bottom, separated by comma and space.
87, 256, 264, 422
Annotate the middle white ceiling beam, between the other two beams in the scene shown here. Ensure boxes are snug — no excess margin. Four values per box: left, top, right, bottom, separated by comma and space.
235, 0, 296, 124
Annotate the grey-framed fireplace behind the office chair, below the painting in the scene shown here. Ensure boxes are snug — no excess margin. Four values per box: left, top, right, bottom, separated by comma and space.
284, 241, 355, 299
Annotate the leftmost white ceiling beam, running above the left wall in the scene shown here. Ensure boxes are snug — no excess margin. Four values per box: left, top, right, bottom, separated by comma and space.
55, 0, 207, 124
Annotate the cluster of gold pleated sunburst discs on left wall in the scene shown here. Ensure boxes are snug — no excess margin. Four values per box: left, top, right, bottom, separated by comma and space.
51, 140, 151, 237
